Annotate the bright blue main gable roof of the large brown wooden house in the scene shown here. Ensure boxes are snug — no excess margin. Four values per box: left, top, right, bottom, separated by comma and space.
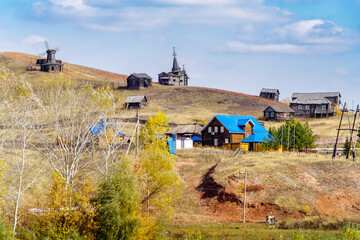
201, 115, 269, 133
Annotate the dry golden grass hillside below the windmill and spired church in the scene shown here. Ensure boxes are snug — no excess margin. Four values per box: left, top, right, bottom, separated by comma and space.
0, 52, 282, 123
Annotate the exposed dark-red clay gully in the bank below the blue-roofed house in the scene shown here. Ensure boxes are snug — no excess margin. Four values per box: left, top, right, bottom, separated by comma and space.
196, 165, 302, 222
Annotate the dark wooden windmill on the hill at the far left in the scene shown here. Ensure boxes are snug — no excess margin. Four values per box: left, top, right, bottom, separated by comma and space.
36, 41, 62, 72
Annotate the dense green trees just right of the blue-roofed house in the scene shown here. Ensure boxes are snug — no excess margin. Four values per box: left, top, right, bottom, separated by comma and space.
263, 118, 316, 151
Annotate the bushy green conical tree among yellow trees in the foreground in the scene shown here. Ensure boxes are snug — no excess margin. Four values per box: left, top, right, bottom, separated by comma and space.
95, 159, 140, 240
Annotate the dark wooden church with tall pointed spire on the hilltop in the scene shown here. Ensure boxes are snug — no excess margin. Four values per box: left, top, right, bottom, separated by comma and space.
158, 48, 189, 86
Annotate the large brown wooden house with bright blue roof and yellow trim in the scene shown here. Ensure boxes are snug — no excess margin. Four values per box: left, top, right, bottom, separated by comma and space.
201, 115, 273, 151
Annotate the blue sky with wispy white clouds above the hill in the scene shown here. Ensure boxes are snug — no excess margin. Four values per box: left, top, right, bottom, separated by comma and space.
0, 0, 360, 106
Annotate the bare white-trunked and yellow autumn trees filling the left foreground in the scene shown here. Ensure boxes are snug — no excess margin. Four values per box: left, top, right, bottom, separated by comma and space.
0, 72, 182, 239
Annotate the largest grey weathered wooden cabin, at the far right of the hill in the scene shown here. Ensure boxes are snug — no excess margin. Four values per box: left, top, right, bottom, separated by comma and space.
290, 92, 341, 118
